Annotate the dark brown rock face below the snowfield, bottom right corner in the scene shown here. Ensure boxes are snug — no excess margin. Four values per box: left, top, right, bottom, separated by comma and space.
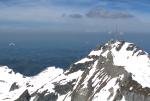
116, 75, 150, 101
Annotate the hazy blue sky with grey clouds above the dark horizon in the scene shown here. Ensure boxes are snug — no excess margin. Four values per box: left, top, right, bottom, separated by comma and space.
0, 0, 150, 32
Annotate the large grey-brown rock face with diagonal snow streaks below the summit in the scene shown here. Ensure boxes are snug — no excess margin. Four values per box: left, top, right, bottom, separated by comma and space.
69, 53, 128, 101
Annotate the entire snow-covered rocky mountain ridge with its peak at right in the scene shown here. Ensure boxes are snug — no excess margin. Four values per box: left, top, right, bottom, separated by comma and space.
0, 40, 150, 101
